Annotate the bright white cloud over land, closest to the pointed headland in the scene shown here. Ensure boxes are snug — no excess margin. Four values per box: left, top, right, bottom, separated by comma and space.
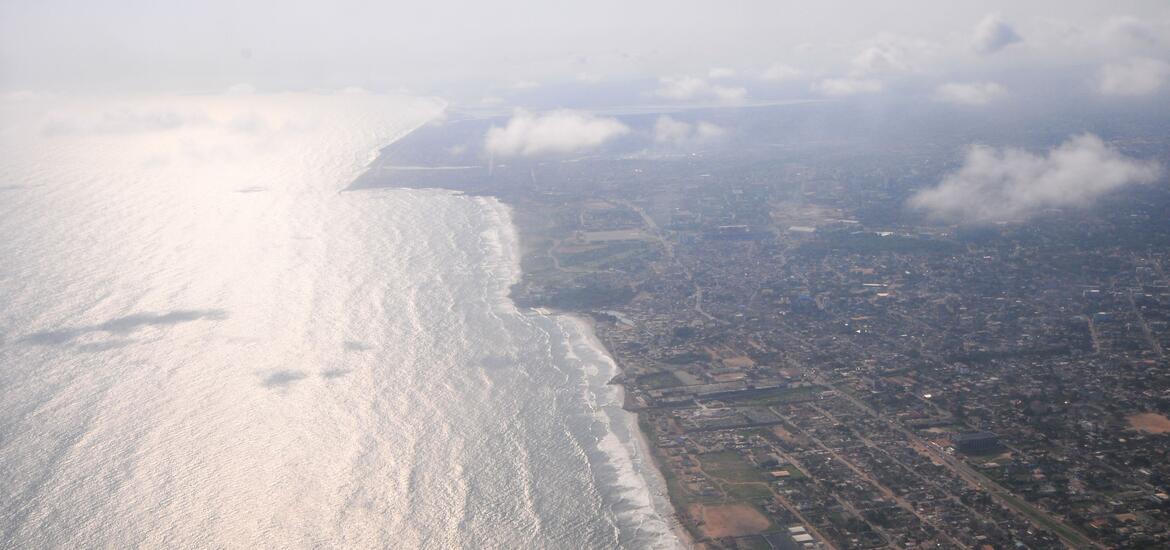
483, 110, 629, 157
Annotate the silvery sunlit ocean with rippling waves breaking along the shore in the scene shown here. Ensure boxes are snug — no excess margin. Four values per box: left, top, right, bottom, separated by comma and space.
0, 92, 680, 549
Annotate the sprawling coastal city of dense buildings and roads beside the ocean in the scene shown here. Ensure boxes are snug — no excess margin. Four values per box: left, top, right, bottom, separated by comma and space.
355, 101, 1170, 549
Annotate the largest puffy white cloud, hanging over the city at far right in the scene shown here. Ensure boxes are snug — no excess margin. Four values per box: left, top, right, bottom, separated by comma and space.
909, 133, 1162, 222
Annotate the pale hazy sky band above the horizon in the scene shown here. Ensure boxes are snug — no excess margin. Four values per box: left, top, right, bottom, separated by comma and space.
0, 0, 1170, 94
